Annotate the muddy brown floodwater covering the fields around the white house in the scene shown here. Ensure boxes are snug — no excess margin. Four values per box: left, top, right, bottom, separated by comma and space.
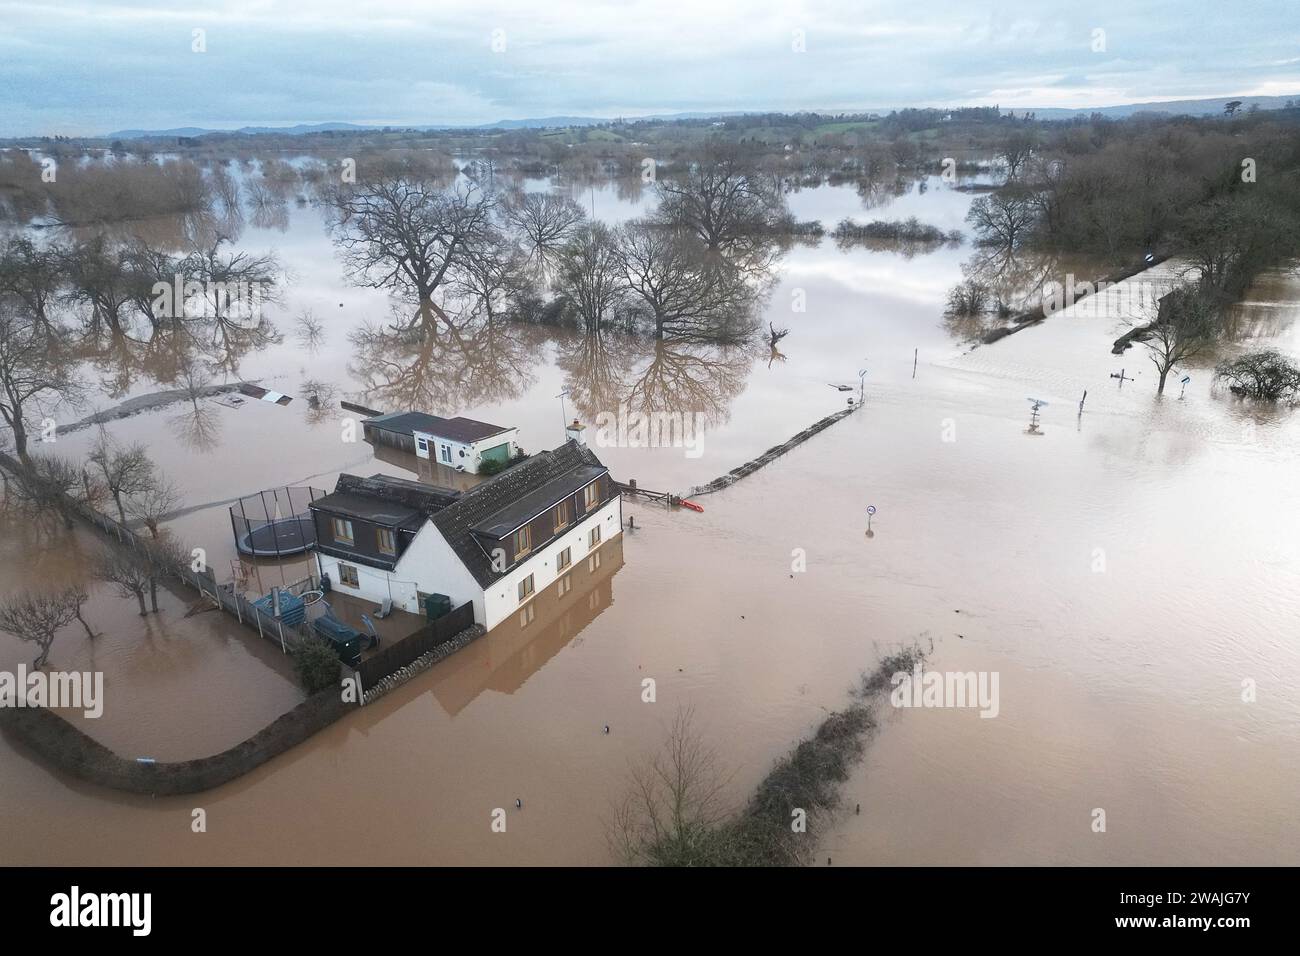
0, 166, 1300, 865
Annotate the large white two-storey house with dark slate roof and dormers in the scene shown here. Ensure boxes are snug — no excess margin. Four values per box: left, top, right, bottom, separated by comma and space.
311, 432, 623, 630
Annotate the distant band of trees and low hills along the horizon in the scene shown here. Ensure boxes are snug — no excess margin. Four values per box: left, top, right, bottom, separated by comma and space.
0, 108, 1300, 345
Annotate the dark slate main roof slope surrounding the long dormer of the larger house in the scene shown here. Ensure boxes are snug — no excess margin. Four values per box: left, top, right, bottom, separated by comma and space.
433, 441, 608, 588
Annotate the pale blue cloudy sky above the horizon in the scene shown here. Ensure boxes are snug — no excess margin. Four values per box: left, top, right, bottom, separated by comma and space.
0, 0, 1300, 135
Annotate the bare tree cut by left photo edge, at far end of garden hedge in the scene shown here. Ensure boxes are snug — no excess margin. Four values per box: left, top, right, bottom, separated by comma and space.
0, 295, 81, 460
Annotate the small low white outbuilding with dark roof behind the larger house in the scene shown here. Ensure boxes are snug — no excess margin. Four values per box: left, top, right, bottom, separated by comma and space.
361, 411, 519, 475
